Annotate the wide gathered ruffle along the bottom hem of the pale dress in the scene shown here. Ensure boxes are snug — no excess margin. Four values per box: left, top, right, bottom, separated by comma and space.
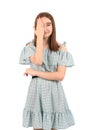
23, 108, 75, 130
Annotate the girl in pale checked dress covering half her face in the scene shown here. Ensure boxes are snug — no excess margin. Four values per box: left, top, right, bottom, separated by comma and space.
19, 12, 74, 130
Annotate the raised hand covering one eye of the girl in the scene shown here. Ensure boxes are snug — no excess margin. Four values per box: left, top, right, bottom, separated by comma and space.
34, 18, 44, 39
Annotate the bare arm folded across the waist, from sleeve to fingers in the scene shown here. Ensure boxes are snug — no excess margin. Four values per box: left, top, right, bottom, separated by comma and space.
24, 66, 66, 81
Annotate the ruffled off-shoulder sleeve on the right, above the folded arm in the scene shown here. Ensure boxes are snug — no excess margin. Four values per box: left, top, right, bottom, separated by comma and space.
58, 42, 75, 67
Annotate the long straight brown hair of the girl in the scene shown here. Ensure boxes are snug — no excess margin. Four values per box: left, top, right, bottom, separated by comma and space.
33, 12, 60, 51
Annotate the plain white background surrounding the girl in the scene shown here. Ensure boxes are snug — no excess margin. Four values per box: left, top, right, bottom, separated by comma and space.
0, 0, 87, 130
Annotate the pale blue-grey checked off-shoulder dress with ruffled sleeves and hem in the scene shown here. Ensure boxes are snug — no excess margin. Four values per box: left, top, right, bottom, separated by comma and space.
19, 42, 75, 130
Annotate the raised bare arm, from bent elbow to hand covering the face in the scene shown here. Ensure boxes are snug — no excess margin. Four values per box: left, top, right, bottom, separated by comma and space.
30, 18, 44, 65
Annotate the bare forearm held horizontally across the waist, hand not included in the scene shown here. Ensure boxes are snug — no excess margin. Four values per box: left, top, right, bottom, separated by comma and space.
36, 71, 64, 81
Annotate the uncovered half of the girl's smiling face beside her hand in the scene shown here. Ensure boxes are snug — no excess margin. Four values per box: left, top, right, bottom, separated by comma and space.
41, 17, 52, 38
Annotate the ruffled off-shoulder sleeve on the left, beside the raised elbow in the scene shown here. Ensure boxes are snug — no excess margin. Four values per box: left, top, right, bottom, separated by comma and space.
19, 42, 35, 65
